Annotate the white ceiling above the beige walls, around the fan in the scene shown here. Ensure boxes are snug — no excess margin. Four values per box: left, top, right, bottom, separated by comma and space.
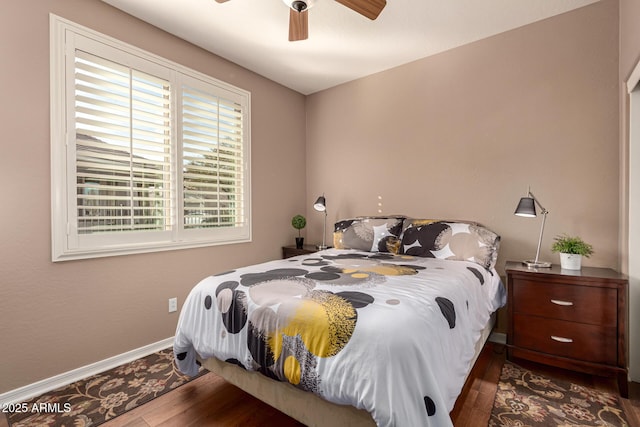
103, 0, 597, 95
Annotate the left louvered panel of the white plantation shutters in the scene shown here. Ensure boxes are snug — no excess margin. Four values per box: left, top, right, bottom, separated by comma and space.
75, 51, 171, 234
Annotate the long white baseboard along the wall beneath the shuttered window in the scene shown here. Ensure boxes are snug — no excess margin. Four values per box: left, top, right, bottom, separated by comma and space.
0, 337, 173, 407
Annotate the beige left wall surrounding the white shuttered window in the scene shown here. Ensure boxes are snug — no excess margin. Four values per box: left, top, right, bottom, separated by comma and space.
0, 0, 306, 393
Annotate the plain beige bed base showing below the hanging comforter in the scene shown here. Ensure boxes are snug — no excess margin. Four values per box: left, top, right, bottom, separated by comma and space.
200, 313, 496, 427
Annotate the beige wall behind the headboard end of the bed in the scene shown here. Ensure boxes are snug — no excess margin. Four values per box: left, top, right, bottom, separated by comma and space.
307, 0, 619, 274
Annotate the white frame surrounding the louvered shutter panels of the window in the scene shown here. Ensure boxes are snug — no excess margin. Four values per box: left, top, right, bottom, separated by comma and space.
50, 14, 252, 262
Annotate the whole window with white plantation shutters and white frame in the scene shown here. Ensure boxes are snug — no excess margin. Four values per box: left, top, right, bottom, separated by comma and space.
51, 15, 251, 261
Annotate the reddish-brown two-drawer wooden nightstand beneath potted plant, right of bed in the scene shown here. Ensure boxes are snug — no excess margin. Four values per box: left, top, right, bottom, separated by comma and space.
505, 262, 629, 398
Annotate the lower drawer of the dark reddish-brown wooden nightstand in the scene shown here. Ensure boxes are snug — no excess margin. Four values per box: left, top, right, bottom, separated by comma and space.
513, 314, 617, 365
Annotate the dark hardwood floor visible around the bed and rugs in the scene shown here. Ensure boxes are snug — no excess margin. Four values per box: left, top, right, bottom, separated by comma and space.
0, 343, 640, 427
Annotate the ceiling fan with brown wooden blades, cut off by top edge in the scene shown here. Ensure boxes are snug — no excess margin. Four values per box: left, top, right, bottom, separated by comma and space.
216, 0, 387, 41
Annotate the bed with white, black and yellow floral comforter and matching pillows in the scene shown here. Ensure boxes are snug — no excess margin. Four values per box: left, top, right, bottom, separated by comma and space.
174, 217, 506, 426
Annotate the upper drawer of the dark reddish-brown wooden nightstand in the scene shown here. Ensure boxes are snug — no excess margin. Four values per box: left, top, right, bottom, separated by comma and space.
513, 280, 618, 326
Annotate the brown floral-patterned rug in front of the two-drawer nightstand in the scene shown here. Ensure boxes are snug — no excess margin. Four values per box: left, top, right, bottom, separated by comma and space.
489, 362, 629, 427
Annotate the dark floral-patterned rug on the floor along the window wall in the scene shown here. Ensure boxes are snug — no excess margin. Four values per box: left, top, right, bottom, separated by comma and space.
7, 348, 207, 427
